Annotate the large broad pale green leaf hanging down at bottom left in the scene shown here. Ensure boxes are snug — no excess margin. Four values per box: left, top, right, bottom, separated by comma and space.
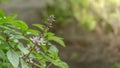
7, 50, 19, 68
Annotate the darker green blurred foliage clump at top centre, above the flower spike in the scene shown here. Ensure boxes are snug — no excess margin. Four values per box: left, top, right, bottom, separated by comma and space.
43, 0, 73, 24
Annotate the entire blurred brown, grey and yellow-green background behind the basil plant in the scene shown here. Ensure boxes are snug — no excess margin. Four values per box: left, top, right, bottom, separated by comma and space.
0, 0, 120, 68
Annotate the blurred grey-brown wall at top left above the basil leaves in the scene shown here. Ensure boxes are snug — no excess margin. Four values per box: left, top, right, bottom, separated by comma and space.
0, 0, 45, 24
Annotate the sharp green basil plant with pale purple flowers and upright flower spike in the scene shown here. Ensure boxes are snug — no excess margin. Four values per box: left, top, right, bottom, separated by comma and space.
0, 11, 68, 68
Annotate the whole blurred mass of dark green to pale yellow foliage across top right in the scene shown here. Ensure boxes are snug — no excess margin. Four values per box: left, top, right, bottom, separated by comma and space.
46, 0, 120, 31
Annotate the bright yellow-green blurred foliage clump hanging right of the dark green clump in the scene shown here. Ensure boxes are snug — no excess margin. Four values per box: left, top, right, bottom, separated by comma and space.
71, 0, 96, 30
